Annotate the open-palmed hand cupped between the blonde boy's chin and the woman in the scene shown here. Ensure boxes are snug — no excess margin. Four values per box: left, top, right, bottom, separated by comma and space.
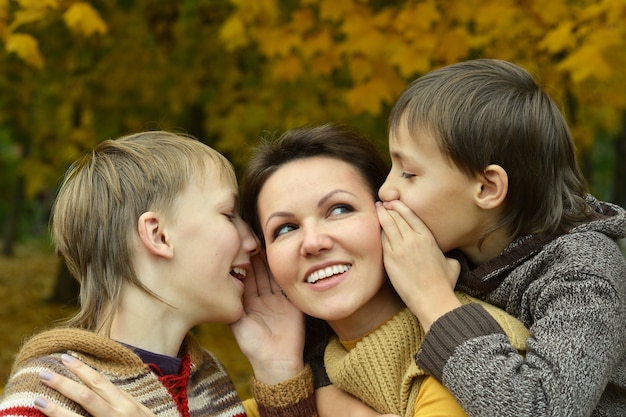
230, 253, 305, 384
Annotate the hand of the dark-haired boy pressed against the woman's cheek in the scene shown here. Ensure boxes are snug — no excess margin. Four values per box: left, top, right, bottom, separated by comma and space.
377, 200, 461, 331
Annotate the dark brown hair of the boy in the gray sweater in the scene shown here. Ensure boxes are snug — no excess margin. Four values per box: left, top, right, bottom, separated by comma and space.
389, 59, 589, 237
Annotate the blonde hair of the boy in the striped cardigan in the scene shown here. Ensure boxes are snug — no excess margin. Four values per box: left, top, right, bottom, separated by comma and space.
51, 131, 237, 331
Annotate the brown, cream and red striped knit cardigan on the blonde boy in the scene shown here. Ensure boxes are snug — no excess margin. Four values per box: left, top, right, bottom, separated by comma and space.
0, 328, 317, 417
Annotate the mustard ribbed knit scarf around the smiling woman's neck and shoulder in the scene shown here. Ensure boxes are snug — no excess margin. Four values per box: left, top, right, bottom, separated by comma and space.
324, 293, 528, 417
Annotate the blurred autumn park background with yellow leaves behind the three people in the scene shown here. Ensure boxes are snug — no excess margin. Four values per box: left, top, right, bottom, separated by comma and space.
0, 0, 626, 395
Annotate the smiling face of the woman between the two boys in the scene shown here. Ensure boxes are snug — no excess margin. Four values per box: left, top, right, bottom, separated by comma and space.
258, 157, 387, 322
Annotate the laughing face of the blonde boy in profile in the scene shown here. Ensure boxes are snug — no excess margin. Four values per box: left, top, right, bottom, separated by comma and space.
161, 164, 257, 324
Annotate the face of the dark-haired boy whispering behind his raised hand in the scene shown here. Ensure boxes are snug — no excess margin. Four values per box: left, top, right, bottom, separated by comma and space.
379, 117, 484, 252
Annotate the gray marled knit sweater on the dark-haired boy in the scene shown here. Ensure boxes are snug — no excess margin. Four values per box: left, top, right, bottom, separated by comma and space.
415, 196, 626, 417
